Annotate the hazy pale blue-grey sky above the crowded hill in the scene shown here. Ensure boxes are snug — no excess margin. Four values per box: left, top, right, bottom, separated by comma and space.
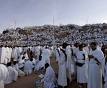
0, 0, 107, 30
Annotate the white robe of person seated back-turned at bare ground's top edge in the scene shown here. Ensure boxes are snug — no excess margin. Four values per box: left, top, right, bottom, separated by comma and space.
24, 60, 33, 75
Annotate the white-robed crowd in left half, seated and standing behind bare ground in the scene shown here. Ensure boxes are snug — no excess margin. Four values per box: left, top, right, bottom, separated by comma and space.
0, 46, 51, 88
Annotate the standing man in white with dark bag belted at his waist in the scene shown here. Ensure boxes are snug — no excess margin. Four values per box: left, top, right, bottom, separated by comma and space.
76, 44, 88, 88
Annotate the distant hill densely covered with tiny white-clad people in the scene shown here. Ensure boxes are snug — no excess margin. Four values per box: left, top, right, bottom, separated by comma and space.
0, 23, 107, 46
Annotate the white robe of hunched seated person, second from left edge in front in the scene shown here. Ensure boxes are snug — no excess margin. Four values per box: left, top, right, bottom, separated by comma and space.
5, 66, 18, 84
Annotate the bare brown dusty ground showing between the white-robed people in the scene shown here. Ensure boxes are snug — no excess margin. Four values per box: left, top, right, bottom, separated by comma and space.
5, 56, 78, 88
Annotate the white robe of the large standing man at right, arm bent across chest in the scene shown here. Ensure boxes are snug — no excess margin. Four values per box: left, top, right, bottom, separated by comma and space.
88, 49, 104, 88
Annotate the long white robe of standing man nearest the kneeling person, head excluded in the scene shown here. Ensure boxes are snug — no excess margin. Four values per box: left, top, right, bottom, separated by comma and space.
58, 50, 67, 87
